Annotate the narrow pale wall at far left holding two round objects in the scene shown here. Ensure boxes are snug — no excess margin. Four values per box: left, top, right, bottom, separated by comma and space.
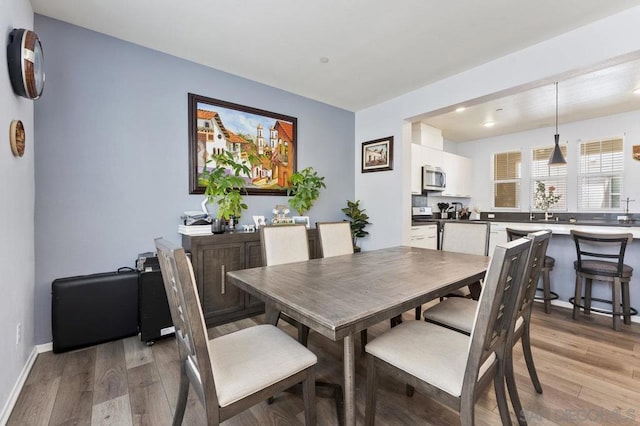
0, 0, 35, 416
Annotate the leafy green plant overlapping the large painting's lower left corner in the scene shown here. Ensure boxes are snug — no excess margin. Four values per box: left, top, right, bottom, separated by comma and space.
199, 151, 251, 233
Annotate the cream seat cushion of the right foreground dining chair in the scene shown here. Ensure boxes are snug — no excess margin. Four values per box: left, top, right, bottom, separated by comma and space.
367, 322, 496, 396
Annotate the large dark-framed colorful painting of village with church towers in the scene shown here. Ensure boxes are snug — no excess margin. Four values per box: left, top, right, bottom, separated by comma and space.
189, 94, 297, 195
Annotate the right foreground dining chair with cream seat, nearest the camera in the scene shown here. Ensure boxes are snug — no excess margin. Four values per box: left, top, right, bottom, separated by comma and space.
365, 238, 531, 426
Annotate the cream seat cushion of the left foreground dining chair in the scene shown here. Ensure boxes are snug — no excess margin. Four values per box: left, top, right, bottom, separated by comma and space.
208, 324, 317, 407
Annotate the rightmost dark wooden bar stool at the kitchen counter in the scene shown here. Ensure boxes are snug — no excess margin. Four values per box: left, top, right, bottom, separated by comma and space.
569, 230, 638, 331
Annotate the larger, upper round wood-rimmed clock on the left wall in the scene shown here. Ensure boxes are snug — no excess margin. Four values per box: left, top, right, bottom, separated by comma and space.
7, 28, 44, 99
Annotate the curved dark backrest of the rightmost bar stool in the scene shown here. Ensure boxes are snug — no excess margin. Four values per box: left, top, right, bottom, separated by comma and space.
571, 229, 633, 277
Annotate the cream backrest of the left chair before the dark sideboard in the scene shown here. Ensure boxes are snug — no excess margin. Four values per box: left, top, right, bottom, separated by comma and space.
260, 225, 309, 266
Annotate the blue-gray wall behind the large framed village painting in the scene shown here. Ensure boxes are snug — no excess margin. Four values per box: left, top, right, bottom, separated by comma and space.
35, 15, 355, 343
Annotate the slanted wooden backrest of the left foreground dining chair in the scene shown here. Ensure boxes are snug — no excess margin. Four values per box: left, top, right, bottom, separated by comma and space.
155, 238, 217, 408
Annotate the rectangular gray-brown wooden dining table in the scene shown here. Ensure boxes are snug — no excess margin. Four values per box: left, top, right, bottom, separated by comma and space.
226, 246, 490, 426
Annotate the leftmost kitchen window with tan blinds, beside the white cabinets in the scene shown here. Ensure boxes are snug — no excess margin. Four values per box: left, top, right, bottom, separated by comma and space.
493, 151, 522, 209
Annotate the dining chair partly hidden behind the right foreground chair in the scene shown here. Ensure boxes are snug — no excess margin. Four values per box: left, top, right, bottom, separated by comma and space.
424, 230, 551, 425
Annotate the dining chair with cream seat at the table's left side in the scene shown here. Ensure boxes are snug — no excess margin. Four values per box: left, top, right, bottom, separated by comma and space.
155, 238, 318, 426
